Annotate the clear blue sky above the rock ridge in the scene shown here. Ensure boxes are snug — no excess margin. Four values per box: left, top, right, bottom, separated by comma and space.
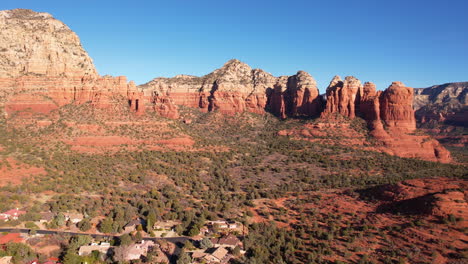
0, 0, 468, 92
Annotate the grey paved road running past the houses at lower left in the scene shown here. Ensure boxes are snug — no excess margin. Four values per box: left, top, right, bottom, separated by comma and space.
0, 228, 190, 244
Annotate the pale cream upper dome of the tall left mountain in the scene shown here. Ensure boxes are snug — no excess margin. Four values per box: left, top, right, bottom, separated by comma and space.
0, 9, 97, 78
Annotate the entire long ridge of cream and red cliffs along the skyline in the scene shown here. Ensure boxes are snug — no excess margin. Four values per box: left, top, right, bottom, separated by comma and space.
0, 9, 454, 162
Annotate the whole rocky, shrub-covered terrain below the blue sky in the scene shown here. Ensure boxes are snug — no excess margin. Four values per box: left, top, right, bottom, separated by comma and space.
0, 9, 468, 264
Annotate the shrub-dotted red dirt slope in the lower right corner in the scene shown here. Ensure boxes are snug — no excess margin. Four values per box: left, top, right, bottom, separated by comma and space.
250, 178, 468, 263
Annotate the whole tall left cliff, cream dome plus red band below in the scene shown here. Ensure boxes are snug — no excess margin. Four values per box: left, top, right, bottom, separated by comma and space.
0, 9, 144, 115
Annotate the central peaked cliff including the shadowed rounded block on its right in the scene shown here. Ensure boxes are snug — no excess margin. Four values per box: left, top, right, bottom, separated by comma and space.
140, 60, 321, 118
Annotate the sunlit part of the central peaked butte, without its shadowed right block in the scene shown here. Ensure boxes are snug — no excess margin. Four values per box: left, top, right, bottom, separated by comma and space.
140, 60, 275, 115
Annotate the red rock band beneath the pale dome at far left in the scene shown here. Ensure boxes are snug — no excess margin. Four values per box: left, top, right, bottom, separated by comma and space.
0, 76, 144, 114
